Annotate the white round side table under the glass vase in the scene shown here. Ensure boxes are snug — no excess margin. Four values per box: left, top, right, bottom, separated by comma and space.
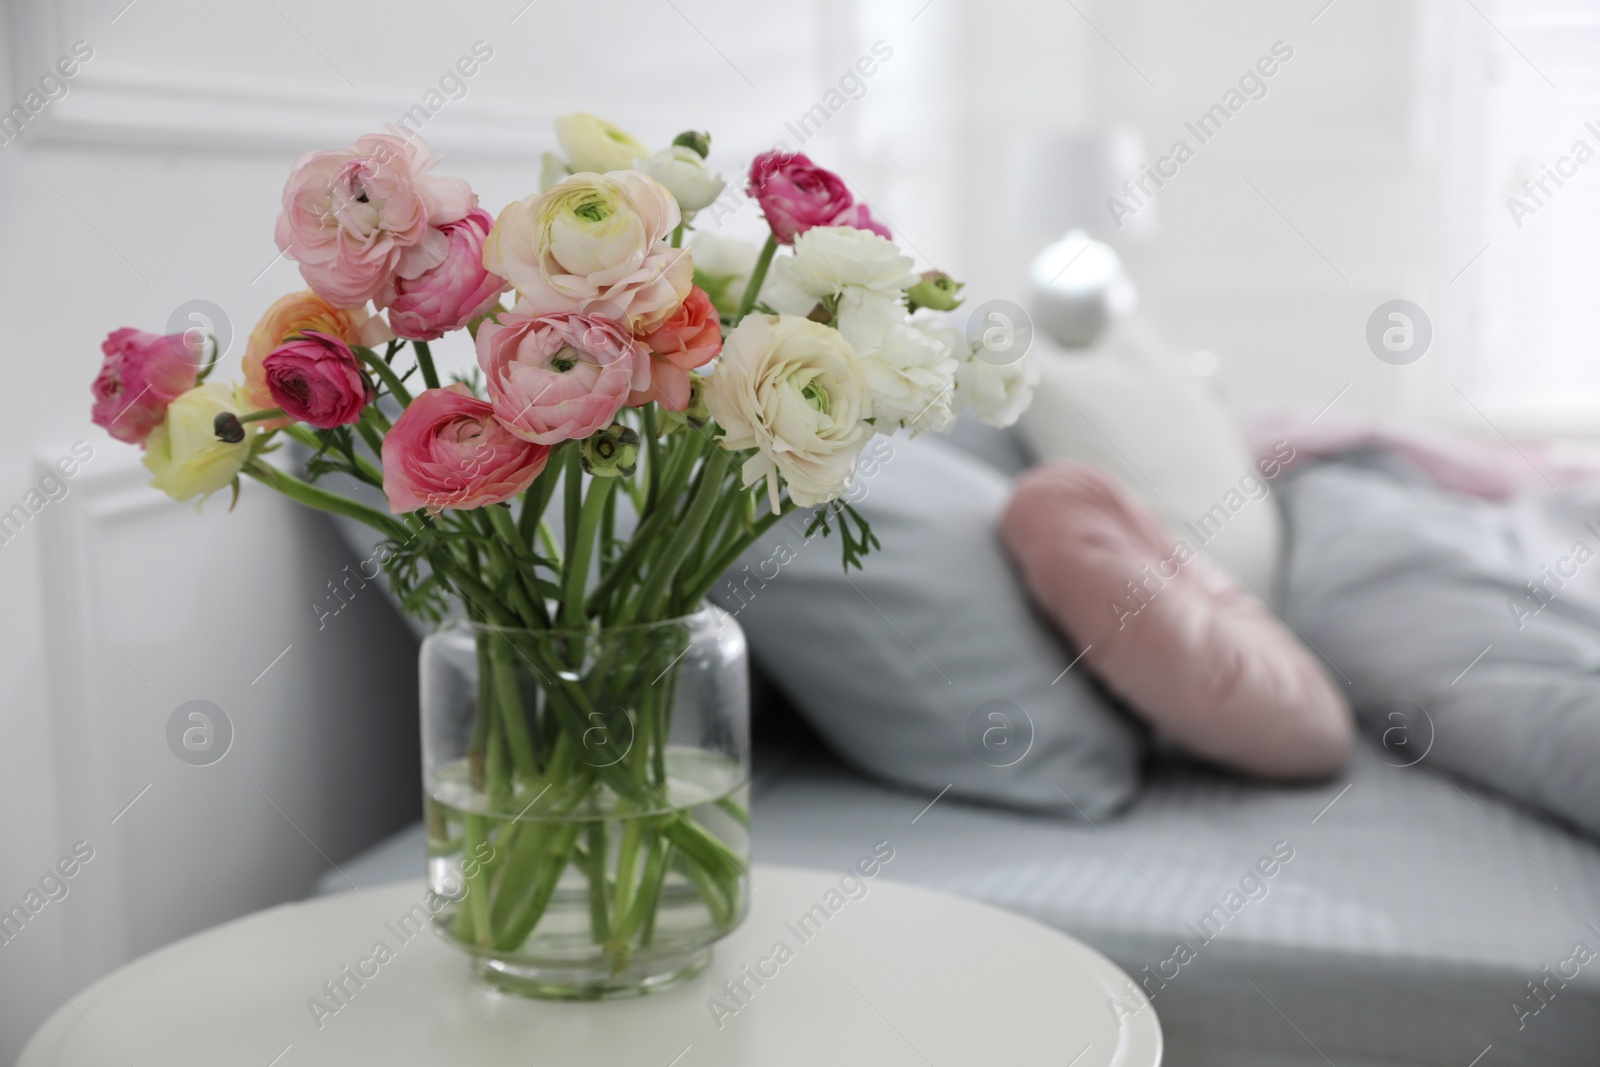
19, 867, 1162, 1067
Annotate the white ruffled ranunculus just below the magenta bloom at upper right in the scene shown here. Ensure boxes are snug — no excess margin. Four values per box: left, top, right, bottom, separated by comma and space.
765, 226, 920, 315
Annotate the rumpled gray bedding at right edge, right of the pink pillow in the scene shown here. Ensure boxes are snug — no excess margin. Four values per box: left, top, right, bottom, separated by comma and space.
1282, 454, 1600, 835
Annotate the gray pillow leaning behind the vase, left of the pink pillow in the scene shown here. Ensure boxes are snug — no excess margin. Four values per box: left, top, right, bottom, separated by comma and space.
712, 437, 1141, 817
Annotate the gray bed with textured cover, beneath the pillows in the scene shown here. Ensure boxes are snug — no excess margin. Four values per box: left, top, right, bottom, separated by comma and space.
308, 428, 1600, 1067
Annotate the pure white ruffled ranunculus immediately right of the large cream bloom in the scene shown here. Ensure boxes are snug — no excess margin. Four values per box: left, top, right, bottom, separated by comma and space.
835, 288, 966, 435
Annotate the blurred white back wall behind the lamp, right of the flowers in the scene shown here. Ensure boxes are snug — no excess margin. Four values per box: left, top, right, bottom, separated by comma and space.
940, 0, 1515, 435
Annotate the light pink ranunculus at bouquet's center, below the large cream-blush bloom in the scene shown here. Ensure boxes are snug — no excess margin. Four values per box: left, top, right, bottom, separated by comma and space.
478, 310, 651, 445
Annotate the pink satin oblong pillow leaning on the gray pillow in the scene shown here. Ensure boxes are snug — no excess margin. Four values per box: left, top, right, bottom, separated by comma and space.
1002, 462, 1352, 781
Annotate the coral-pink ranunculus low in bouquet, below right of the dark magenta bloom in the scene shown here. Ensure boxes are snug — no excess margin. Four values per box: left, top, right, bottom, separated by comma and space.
382, 384, 550, 515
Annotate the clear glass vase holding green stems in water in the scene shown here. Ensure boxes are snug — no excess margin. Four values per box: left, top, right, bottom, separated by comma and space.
422, 606, 750, 1000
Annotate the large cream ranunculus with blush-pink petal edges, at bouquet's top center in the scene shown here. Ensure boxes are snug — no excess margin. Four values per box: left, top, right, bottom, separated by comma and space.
483, 171, 694, 331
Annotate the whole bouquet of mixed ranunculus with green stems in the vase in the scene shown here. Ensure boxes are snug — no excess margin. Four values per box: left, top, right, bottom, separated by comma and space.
94, 115, 1034, 989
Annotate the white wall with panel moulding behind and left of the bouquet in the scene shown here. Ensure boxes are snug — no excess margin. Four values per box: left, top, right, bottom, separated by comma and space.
0, 0, 960, 1062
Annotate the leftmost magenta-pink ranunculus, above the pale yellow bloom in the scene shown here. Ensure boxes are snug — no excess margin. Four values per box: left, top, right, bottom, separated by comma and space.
93, 326, 200, 445
